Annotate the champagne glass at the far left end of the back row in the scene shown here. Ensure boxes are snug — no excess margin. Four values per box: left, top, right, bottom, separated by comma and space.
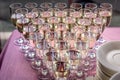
9, 3, 24, 26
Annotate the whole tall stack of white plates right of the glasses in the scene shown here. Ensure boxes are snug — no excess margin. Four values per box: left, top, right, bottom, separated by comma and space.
97, 41, 120, 80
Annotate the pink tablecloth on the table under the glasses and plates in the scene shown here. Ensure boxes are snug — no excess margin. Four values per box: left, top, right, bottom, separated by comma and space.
0, 27, 120, 80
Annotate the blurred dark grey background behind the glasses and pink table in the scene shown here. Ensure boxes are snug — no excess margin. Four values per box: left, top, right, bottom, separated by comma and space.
0, 0, 120, 50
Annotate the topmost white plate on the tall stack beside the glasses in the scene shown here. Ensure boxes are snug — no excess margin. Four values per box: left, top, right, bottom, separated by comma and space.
97, 41, 120, 72
